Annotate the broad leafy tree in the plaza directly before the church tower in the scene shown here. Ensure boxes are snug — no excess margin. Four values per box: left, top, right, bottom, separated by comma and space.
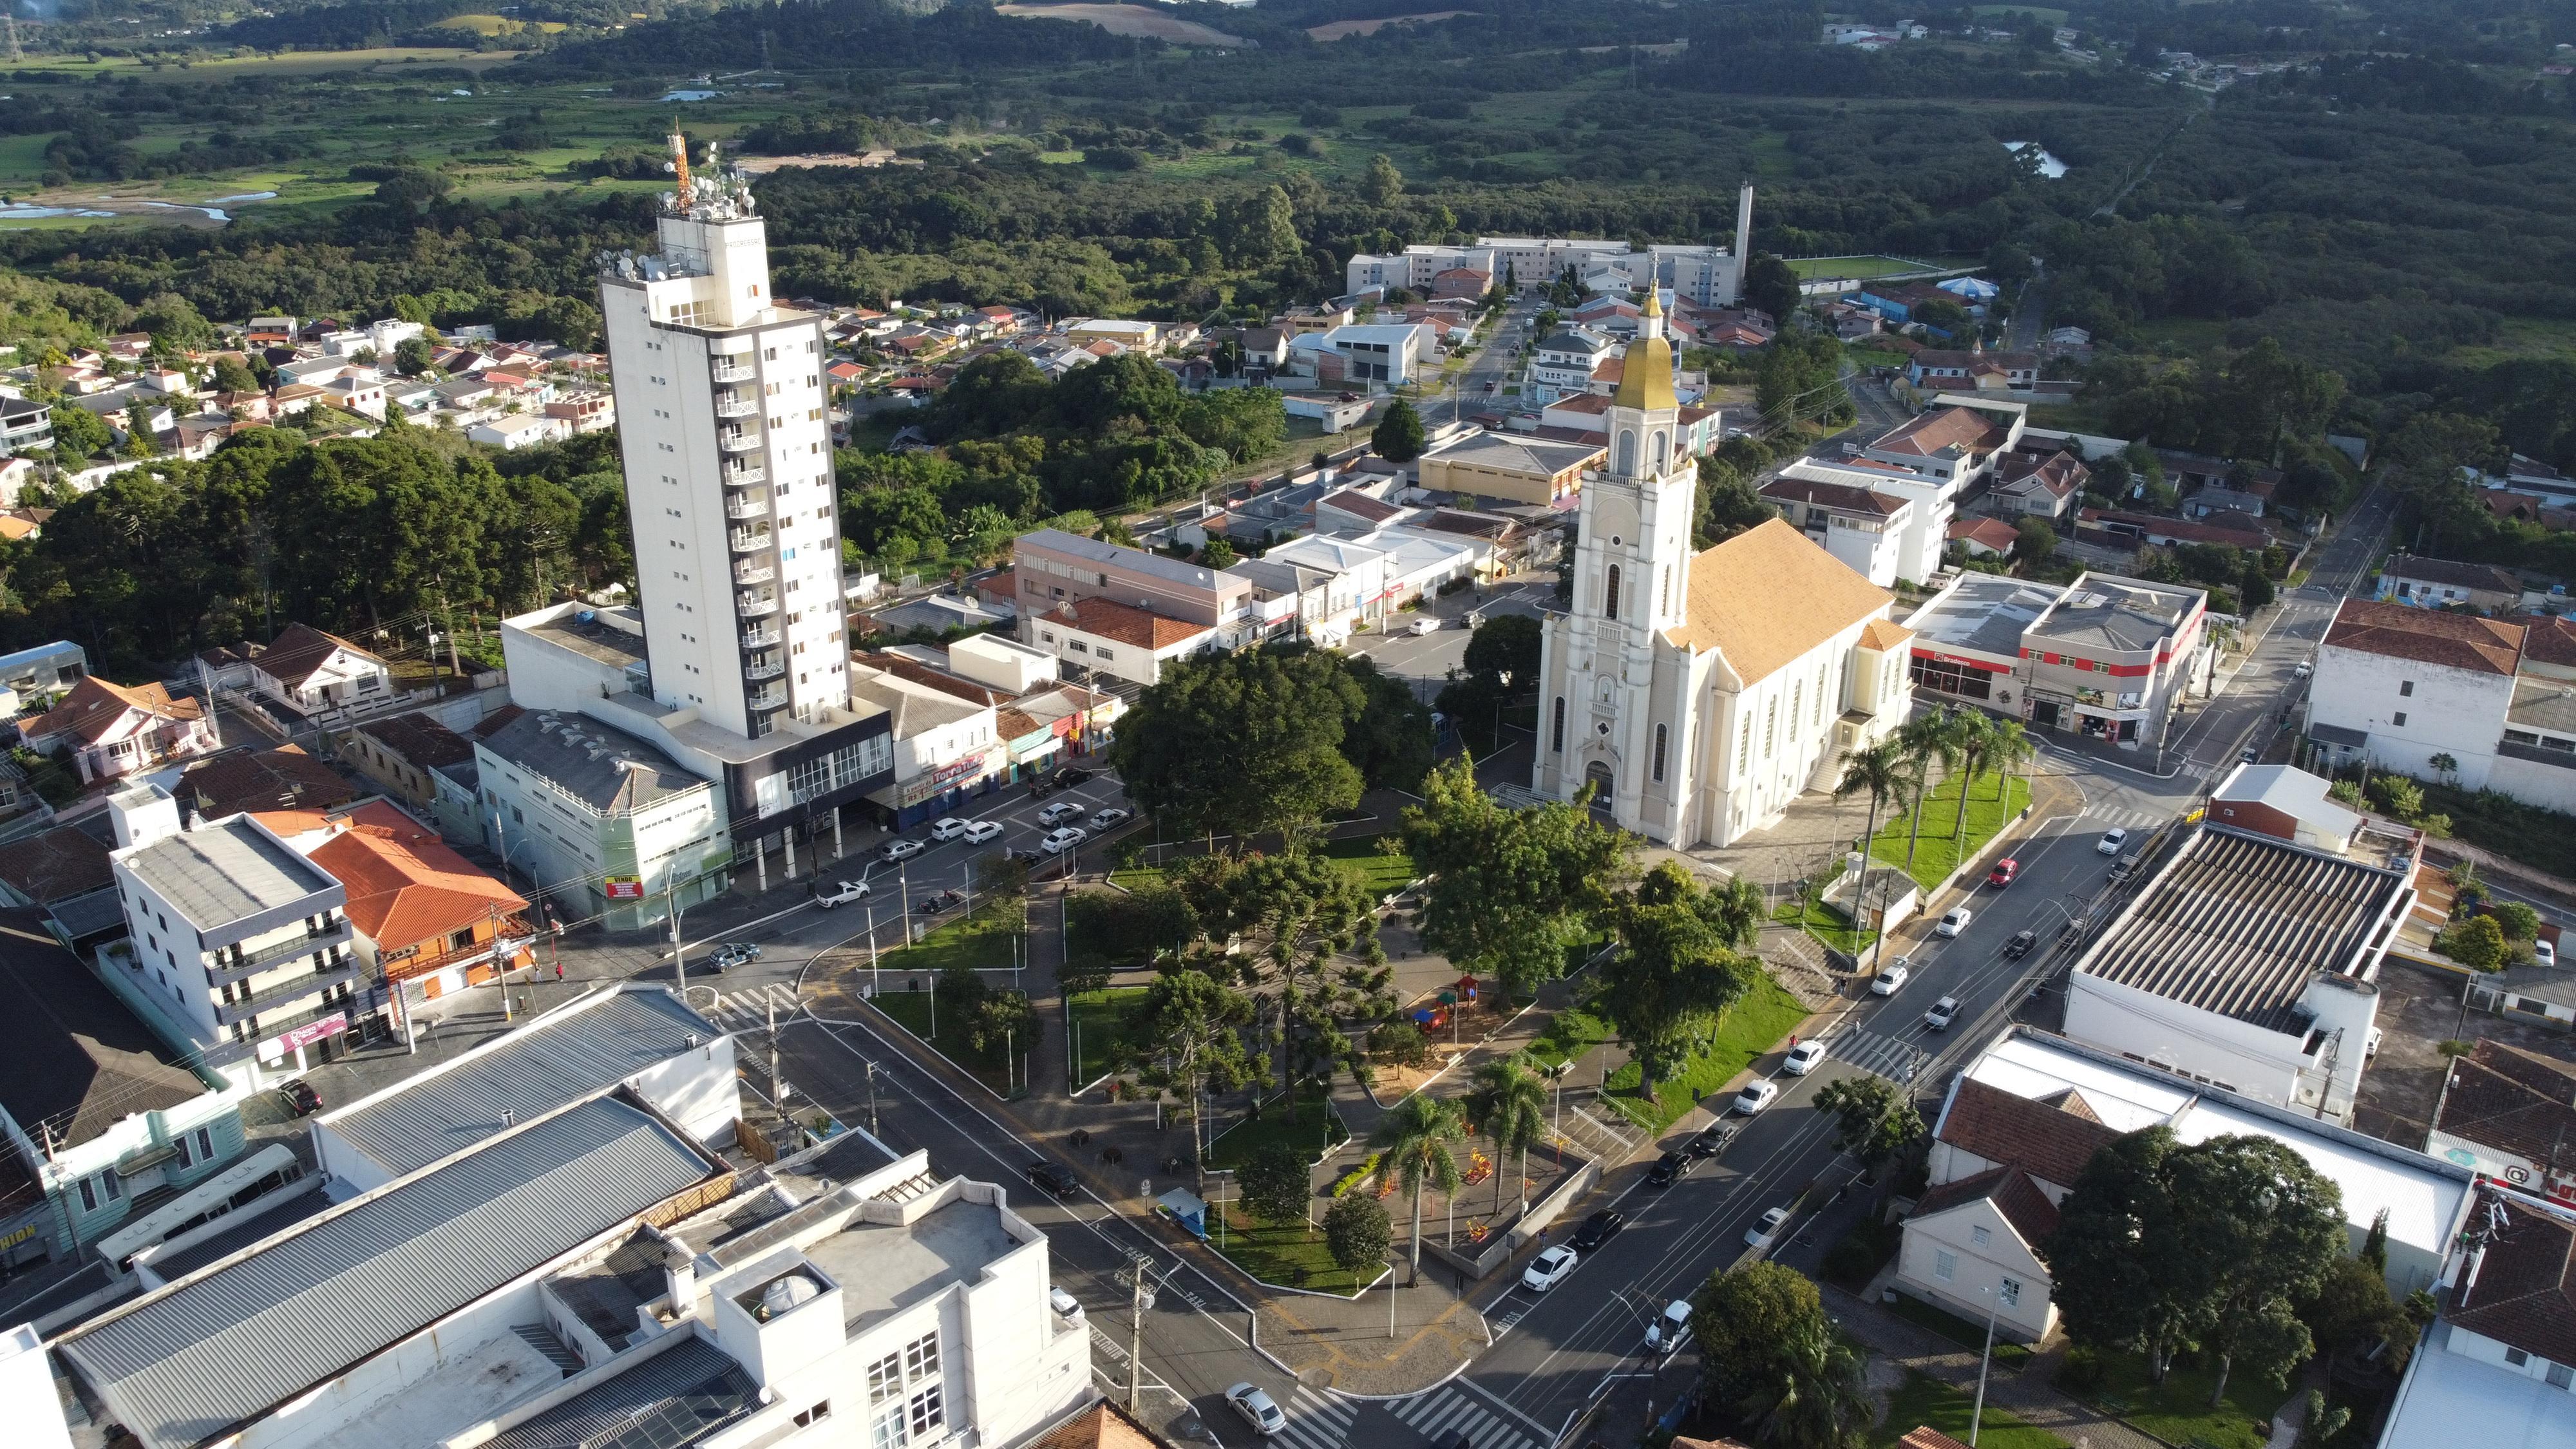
1404, 758, 1636, 995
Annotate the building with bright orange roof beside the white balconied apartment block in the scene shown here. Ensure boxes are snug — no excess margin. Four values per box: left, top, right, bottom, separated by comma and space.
309, 799, 536, 1010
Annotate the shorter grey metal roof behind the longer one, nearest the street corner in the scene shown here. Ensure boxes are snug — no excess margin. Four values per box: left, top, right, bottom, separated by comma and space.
319, 987, 724, 1179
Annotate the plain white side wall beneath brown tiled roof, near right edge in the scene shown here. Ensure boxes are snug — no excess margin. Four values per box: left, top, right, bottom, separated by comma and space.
2308, 645, 2514, 789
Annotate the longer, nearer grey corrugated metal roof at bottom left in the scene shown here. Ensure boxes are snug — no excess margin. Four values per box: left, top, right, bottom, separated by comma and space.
57, 1099, 711, 1449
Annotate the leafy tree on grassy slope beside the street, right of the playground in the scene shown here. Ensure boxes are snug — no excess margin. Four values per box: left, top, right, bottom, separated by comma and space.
1592, 861, 1762, 1101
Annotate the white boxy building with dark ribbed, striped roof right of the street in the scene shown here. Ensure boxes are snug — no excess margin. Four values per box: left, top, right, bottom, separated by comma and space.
2066, 822, 2421, 1122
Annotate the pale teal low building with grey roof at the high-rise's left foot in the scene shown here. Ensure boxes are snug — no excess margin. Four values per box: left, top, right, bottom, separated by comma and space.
474, 709, 734, 931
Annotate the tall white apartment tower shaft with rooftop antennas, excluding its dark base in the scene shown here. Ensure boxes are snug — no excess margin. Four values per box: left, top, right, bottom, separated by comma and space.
600, 137, 850, 740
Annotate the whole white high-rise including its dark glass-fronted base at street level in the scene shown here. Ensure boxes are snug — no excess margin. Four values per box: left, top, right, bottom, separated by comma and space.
585, 137, 891, 876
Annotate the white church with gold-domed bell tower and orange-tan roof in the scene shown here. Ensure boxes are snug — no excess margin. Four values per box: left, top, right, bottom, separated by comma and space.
1530, 291, 1914, 848
